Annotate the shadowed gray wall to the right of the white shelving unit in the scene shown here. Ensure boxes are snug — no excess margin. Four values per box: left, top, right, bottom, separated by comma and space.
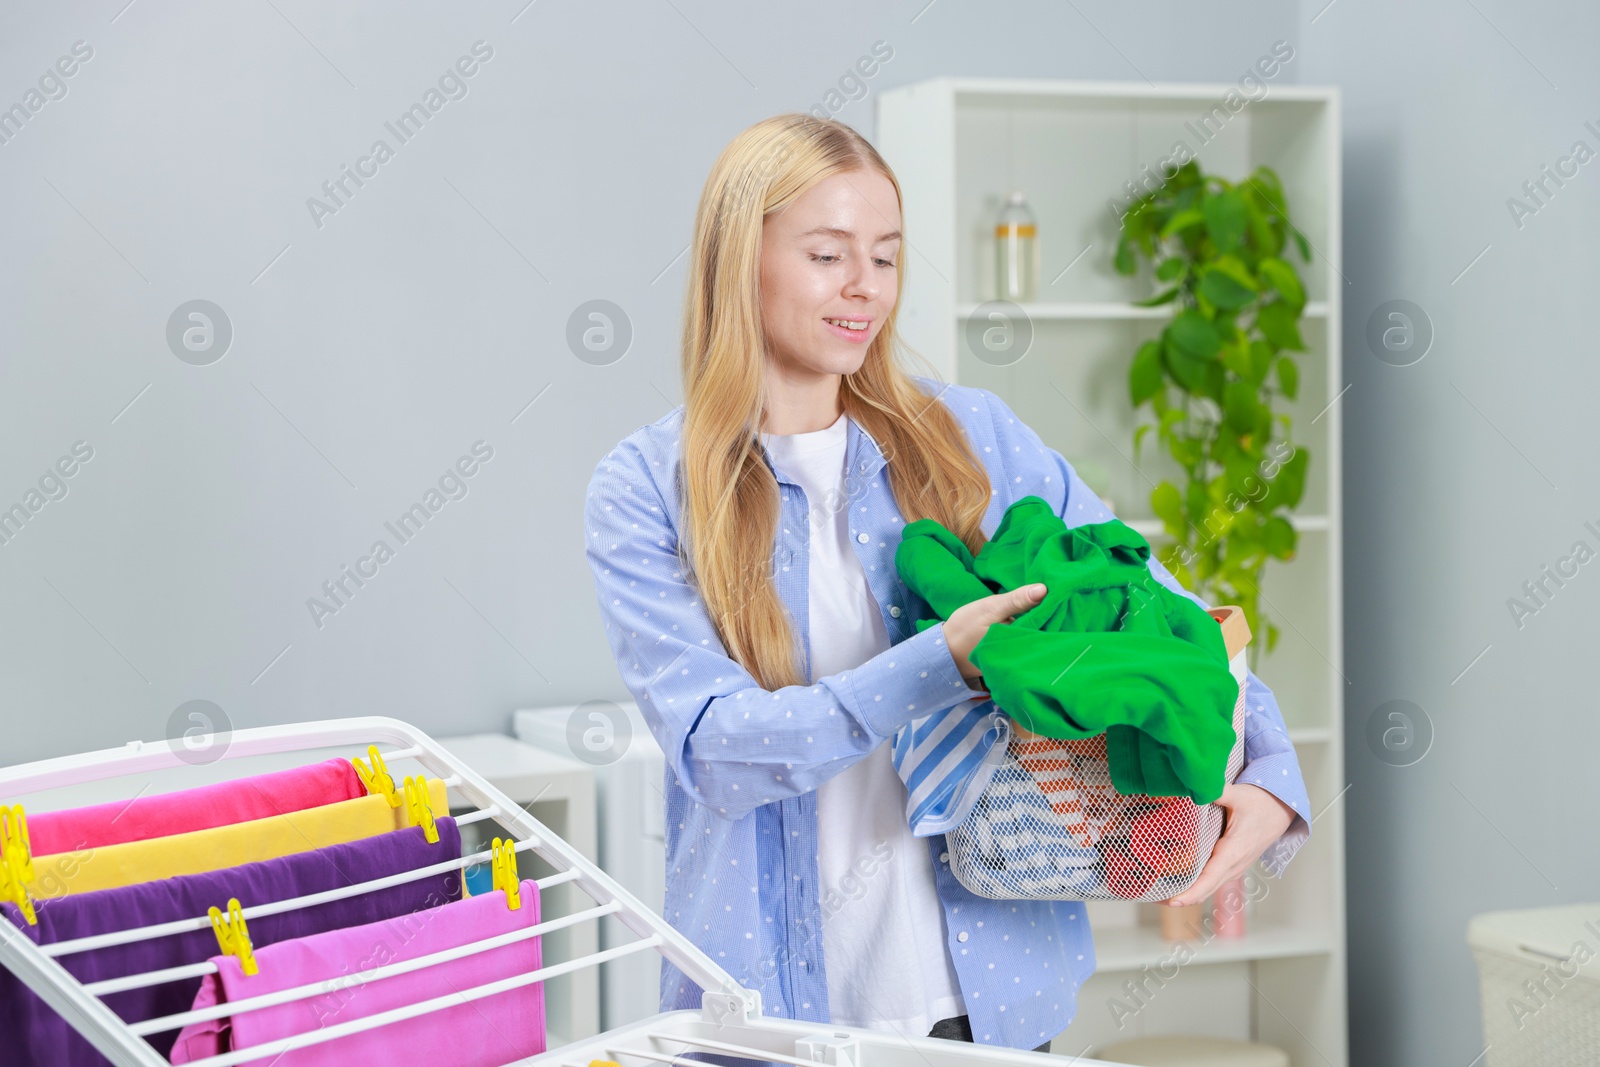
1298, 0, 1600, 1067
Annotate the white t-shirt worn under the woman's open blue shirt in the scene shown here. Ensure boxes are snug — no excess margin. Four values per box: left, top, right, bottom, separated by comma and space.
762, 414, 966, 1037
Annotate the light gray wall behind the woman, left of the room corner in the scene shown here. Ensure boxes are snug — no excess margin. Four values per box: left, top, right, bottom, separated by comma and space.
0, 0, 1296, 760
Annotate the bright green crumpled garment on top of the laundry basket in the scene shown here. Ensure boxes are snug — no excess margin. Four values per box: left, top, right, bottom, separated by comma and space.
894, 496, 1238, 805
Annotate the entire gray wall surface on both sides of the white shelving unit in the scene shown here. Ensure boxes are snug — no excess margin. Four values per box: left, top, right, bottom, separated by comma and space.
0, 0, 1600, 1065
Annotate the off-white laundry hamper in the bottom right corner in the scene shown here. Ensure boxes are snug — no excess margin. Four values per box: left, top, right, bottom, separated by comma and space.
1467, 904, 1600, 1067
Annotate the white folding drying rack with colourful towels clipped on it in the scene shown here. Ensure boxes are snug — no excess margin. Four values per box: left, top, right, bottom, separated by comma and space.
0, 717, 1110, 1067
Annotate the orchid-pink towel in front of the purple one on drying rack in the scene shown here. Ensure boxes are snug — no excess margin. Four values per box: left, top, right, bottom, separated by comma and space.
171, 881, 546, 1067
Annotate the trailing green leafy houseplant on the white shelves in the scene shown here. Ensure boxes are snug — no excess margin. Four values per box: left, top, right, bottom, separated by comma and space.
1115, 160, 1310, 657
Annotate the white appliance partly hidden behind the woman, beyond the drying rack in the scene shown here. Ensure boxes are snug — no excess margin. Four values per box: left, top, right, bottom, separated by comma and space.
512, 701, 667, 1030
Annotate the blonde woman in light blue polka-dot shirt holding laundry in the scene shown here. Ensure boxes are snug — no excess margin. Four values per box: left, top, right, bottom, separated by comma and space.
586, 115, 1309, 1049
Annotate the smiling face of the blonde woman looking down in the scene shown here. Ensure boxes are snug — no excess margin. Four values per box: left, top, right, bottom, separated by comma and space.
762, 171, 901, 391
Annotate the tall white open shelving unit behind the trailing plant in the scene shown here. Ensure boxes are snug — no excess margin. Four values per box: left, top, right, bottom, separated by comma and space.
877, 78, 1349, 1067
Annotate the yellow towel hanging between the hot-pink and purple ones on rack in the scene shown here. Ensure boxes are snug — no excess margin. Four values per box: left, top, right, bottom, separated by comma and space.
29, 777, 450, 901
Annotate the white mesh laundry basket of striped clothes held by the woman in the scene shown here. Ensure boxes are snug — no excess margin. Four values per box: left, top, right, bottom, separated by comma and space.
946, 606, 1250, 901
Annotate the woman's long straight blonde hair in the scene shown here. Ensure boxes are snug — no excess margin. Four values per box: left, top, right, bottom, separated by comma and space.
678, 114, 990, 689
